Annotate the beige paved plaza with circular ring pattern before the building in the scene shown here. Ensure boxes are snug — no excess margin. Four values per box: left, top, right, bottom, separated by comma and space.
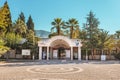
0, 60, 120, 80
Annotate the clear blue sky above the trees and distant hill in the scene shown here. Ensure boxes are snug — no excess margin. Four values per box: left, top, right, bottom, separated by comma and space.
0, 0, 120, 34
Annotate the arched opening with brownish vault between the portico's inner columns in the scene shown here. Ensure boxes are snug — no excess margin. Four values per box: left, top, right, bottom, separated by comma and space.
50, 39, 70, 59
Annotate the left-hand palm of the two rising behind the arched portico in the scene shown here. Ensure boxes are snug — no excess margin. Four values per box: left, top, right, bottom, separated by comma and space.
51, 18, 64, 35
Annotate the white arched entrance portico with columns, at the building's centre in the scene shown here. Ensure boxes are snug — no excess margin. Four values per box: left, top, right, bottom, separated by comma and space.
38, 36, 82, 60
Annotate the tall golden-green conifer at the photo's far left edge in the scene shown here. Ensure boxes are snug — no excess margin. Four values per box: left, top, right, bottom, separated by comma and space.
0, 1, 12, 32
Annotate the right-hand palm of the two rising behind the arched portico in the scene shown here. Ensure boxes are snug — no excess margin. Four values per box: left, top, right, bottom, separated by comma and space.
65, 18, 79, 38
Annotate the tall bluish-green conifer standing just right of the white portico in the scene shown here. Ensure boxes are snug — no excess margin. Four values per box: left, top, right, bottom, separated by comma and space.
83, 11, 100, 58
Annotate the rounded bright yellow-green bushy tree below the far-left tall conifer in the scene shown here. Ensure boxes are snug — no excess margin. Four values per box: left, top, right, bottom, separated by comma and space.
5, 32, 22, 49
